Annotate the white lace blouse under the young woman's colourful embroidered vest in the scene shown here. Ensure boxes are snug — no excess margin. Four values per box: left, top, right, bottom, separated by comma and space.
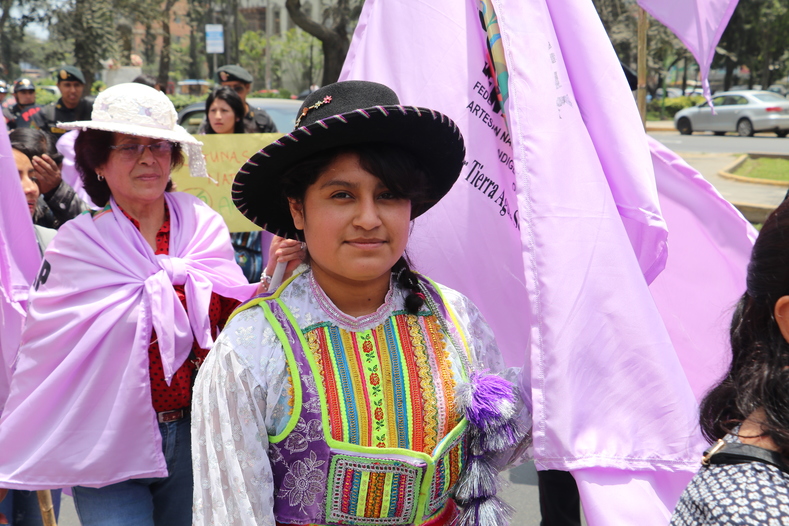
192, 270, 516, 526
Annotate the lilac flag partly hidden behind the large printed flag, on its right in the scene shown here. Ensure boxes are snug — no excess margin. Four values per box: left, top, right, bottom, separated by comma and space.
573, 137, 756, 524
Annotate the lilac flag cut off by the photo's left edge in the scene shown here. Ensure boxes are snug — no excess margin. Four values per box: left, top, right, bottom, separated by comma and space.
0, 126, 41, 413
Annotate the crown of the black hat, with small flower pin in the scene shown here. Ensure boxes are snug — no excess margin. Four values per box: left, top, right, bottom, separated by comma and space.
296, 80, 400, 132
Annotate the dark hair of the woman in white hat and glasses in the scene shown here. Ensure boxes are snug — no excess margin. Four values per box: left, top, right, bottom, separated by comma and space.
74, 128, 184, 206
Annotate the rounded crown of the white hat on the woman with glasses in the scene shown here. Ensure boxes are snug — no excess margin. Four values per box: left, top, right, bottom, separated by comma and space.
91, 83, 178, 130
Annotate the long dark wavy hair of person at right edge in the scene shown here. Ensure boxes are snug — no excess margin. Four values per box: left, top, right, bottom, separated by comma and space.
700, 201, 789, 456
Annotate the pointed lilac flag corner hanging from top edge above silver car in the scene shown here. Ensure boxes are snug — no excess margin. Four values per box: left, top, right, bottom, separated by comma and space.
638, 0, 737, 99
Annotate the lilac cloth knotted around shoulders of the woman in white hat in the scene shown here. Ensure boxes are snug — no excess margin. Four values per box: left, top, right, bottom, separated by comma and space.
0, 193, 256, 490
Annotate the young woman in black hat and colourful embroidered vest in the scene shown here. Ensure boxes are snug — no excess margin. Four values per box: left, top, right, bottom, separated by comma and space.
192, 81, 529, 526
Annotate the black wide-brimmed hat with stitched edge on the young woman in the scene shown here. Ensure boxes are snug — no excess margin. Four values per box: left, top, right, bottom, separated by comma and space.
232, 80, 466, 239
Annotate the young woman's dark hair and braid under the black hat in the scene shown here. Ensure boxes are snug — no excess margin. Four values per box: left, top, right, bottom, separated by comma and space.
283, 143, 432, 314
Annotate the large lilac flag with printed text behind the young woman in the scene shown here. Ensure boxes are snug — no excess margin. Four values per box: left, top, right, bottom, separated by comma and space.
343, 0, 702, 524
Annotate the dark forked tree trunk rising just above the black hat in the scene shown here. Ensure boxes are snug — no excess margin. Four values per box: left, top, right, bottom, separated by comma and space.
285, 0, 364, 86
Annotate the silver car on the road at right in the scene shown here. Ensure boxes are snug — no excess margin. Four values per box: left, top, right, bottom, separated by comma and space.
674, 90, 789, 137
